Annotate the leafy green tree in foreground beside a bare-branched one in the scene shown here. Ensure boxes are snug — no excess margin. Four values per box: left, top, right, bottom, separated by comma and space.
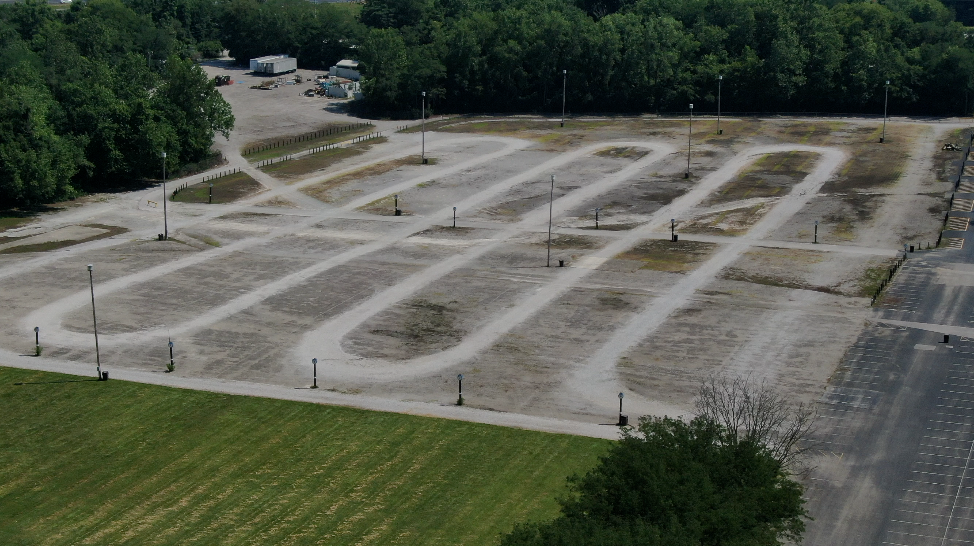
501, 378, 807, 546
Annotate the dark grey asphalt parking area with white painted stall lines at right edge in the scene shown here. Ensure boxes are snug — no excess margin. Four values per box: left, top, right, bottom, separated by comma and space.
804, 139, 974, 546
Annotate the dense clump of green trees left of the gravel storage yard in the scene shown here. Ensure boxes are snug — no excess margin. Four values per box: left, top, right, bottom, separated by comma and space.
0, 0, 234, 208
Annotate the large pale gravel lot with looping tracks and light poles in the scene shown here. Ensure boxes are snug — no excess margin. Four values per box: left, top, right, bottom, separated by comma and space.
0, 74, 961, 434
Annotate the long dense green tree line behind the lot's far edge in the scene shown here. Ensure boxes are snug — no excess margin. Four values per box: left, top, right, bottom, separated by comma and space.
358, 0, 974, 115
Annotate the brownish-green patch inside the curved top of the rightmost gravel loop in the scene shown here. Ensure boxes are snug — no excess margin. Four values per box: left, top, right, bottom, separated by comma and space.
703, 152, 818, 206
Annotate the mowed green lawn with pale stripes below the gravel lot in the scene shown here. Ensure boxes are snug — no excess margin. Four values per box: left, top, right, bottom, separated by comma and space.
0, 368, 609, 546
